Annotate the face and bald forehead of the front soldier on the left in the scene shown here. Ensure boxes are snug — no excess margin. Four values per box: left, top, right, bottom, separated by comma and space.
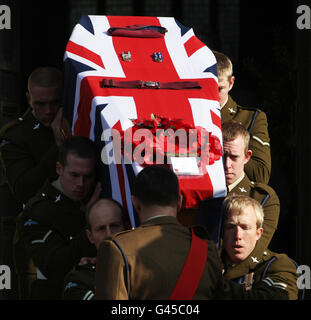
86, 200, 125, 249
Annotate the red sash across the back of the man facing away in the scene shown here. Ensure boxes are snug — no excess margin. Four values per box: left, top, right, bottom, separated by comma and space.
170, 228, 208, 300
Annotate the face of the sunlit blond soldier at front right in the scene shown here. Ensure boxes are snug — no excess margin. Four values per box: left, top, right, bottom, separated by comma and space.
223, 206, 263, 263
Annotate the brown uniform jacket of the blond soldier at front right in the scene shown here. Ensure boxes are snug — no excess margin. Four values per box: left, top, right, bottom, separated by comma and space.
224, 248, 298, 300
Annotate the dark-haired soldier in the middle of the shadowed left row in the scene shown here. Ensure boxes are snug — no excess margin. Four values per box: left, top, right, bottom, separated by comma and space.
16, 136, 100, 299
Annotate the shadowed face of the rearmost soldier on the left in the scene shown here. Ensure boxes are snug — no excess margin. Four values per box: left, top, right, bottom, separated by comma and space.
26, 86, 60, 127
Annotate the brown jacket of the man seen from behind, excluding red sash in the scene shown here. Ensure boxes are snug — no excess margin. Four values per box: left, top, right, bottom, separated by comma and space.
95, 216, 222, 300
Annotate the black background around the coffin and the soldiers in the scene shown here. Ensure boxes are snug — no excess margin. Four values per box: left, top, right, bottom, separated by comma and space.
0, 0, 311, 299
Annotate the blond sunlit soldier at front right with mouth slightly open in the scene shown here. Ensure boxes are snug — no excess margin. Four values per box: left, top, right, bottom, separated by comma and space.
222, 195, 298, 300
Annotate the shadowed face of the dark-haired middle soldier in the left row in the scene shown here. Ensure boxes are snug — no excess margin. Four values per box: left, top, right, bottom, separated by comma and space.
56, 153, 95, 201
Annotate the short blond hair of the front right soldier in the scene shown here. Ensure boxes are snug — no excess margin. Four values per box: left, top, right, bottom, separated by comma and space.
223, 195, 264, 229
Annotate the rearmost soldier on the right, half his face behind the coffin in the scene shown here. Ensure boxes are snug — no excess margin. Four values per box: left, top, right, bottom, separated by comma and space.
214, 51, 271, 184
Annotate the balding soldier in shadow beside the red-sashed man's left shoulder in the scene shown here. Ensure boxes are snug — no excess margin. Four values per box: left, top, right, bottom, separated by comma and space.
63, 198, 129, 300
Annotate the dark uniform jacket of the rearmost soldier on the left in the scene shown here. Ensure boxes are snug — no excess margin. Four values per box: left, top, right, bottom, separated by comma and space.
0, 109, 58, 203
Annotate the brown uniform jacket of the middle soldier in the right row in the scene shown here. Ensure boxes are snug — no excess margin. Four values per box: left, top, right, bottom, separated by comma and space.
227, 175, 280, 249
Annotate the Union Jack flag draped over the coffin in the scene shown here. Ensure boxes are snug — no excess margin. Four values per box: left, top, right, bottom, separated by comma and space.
63, 16, 226, 226
